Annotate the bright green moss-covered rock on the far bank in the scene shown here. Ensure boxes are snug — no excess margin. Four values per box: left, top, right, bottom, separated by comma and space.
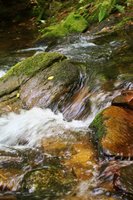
42, 12, 88, 37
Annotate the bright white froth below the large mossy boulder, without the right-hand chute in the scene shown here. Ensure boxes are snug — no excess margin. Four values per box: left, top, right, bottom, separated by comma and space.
0, 108, 87, 147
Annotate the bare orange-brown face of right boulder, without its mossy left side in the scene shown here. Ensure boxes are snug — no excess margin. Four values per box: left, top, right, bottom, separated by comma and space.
101, 106, 133, 157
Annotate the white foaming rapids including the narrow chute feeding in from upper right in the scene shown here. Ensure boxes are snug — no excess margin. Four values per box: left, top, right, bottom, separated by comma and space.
0, 76, 130, 148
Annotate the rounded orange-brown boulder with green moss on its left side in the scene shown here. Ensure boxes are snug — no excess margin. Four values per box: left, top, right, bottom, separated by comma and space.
90, 106, 133, 157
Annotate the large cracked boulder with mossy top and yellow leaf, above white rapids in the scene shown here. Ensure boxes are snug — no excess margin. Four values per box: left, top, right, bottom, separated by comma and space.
0, 52, 89, 120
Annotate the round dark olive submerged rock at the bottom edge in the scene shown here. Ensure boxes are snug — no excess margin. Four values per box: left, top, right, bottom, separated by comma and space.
22, 166, 76, 198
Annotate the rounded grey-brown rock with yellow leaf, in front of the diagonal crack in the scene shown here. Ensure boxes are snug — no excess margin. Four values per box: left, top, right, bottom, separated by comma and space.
20, 59, 79, 108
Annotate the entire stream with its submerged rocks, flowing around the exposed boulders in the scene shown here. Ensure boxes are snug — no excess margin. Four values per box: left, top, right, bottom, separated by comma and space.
0, 23, 133, 200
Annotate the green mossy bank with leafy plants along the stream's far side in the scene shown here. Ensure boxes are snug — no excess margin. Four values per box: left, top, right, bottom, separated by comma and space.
35, 0, 133, 39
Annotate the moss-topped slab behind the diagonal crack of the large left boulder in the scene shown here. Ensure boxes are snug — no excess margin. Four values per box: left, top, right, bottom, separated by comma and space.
0, 53, 66, 114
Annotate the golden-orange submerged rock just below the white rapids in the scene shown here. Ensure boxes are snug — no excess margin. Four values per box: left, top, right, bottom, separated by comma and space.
42, 131, 97, 180
